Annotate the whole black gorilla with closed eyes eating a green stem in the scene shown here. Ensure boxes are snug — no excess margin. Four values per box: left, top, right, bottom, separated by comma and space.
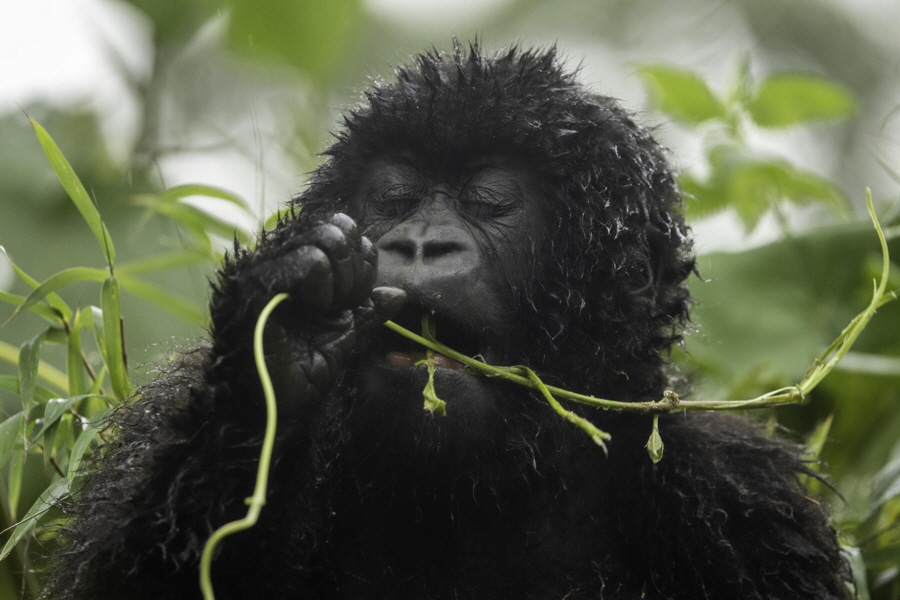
47, 44, 850, 600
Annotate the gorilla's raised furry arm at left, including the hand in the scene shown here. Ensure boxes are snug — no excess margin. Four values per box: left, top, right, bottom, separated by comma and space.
53, 215, 403, 598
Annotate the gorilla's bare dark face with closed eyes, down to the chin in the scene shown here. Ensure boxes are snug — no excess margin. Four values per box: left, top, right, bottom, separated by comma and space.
342, 159, 545, 448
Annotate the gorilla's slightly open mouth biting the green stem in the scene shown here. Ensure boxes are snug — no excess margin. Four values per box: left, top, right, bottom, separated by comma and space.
380, 302, 489, 371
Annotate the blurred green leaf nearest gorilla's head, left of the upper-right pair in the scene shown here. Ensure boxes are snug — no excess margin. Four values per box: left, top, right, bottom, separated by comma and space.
637, 66, 726, 125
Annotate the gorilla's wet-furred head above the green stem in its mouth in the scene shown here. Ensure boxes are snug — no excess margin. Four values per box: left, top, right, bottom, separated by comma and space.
299, 46, 693, 410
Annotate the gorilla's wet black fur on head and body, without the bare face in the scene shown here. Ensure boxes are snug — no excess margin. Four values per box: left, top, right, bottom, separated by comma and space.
49, 47, 848, 600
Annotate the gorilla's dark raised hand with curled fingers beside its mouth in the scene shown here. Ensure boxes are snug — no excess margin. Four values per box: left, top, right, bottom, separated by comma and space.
213, 214, 405, 403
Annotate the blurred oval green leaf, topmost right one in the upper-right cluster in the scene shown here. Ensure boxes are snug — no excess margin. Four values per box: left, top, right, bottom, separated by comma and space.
748, 73, 856, 127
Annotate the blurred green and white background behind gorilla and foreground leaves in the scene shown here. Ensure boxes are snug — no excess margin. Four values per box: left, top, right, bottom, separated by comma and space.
0, 0, 900, 599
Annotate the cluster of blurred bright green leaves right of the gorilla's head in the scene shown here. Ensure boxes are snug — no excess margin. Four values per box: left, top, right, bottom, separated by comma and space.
638, 64, 856, 231
